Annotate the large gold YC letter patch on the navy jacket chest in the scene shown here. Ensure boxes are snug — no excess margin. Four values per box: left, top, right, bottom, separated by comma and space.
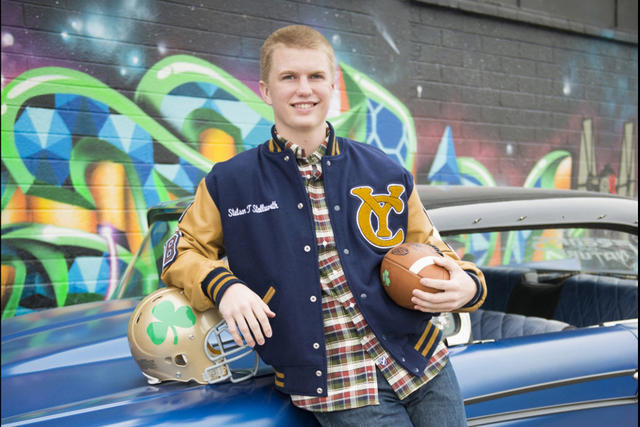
351, 184, 405, 248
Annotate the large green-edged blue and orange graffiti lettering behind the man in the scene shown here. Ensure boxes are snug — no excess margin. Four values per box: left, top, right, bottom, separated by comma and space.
2, 55, 416, 318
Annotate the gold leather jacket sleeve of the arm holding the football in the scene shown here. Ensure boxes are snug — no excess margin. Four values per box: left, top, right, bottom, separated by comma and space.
406, 187, 487, 313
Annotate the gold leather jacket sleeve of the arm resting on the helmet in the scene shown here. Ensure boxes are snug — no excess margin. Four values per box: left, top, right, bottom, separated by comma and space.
161, 179, 228, 311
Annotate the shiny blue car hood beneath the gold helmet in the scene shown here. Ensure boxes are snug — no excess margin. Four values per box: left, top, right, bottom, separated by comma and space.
2, 300, 315, 426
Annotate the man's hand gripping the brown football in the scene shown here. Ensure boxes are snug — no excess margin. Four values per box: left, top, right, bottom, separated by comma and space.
411, 257, 478, 313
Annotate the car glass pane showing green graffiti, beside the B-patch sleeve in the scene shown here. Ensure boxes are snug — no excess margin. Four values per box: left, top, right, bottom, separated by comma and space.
112, 221, 178, 299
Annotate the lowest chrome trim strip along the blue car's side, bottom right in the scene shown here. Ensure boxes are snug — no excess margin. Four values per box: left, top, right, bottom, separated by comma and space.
467, 395, 638, 427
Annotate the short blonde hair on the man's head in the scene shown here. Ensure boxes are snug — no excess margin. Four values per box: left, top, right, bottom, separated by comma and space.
260, 25, 336, 83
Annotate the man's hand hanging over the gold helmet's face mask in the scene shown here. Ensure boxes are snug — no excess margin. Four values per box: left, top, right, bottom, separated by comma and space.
218, 283, 276, 347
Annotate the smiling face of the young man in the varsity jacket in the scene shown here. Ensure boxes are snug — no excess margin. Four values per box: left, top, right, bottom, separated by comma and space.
260, 46, 334, 150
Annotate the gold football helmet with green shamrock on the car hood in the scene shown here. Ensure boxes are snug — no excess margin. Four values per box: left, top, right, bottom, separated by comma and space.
127, 286, 260, 384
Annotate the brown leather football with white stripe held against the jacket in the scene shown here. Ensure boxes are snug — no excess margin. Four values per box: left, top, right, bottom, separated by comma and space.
380, 243, 449, 310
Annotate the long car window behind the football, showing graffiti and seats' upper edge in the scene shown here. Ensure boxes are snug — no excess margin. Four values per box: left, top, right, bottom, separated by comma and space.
443, 228, 638, 275
